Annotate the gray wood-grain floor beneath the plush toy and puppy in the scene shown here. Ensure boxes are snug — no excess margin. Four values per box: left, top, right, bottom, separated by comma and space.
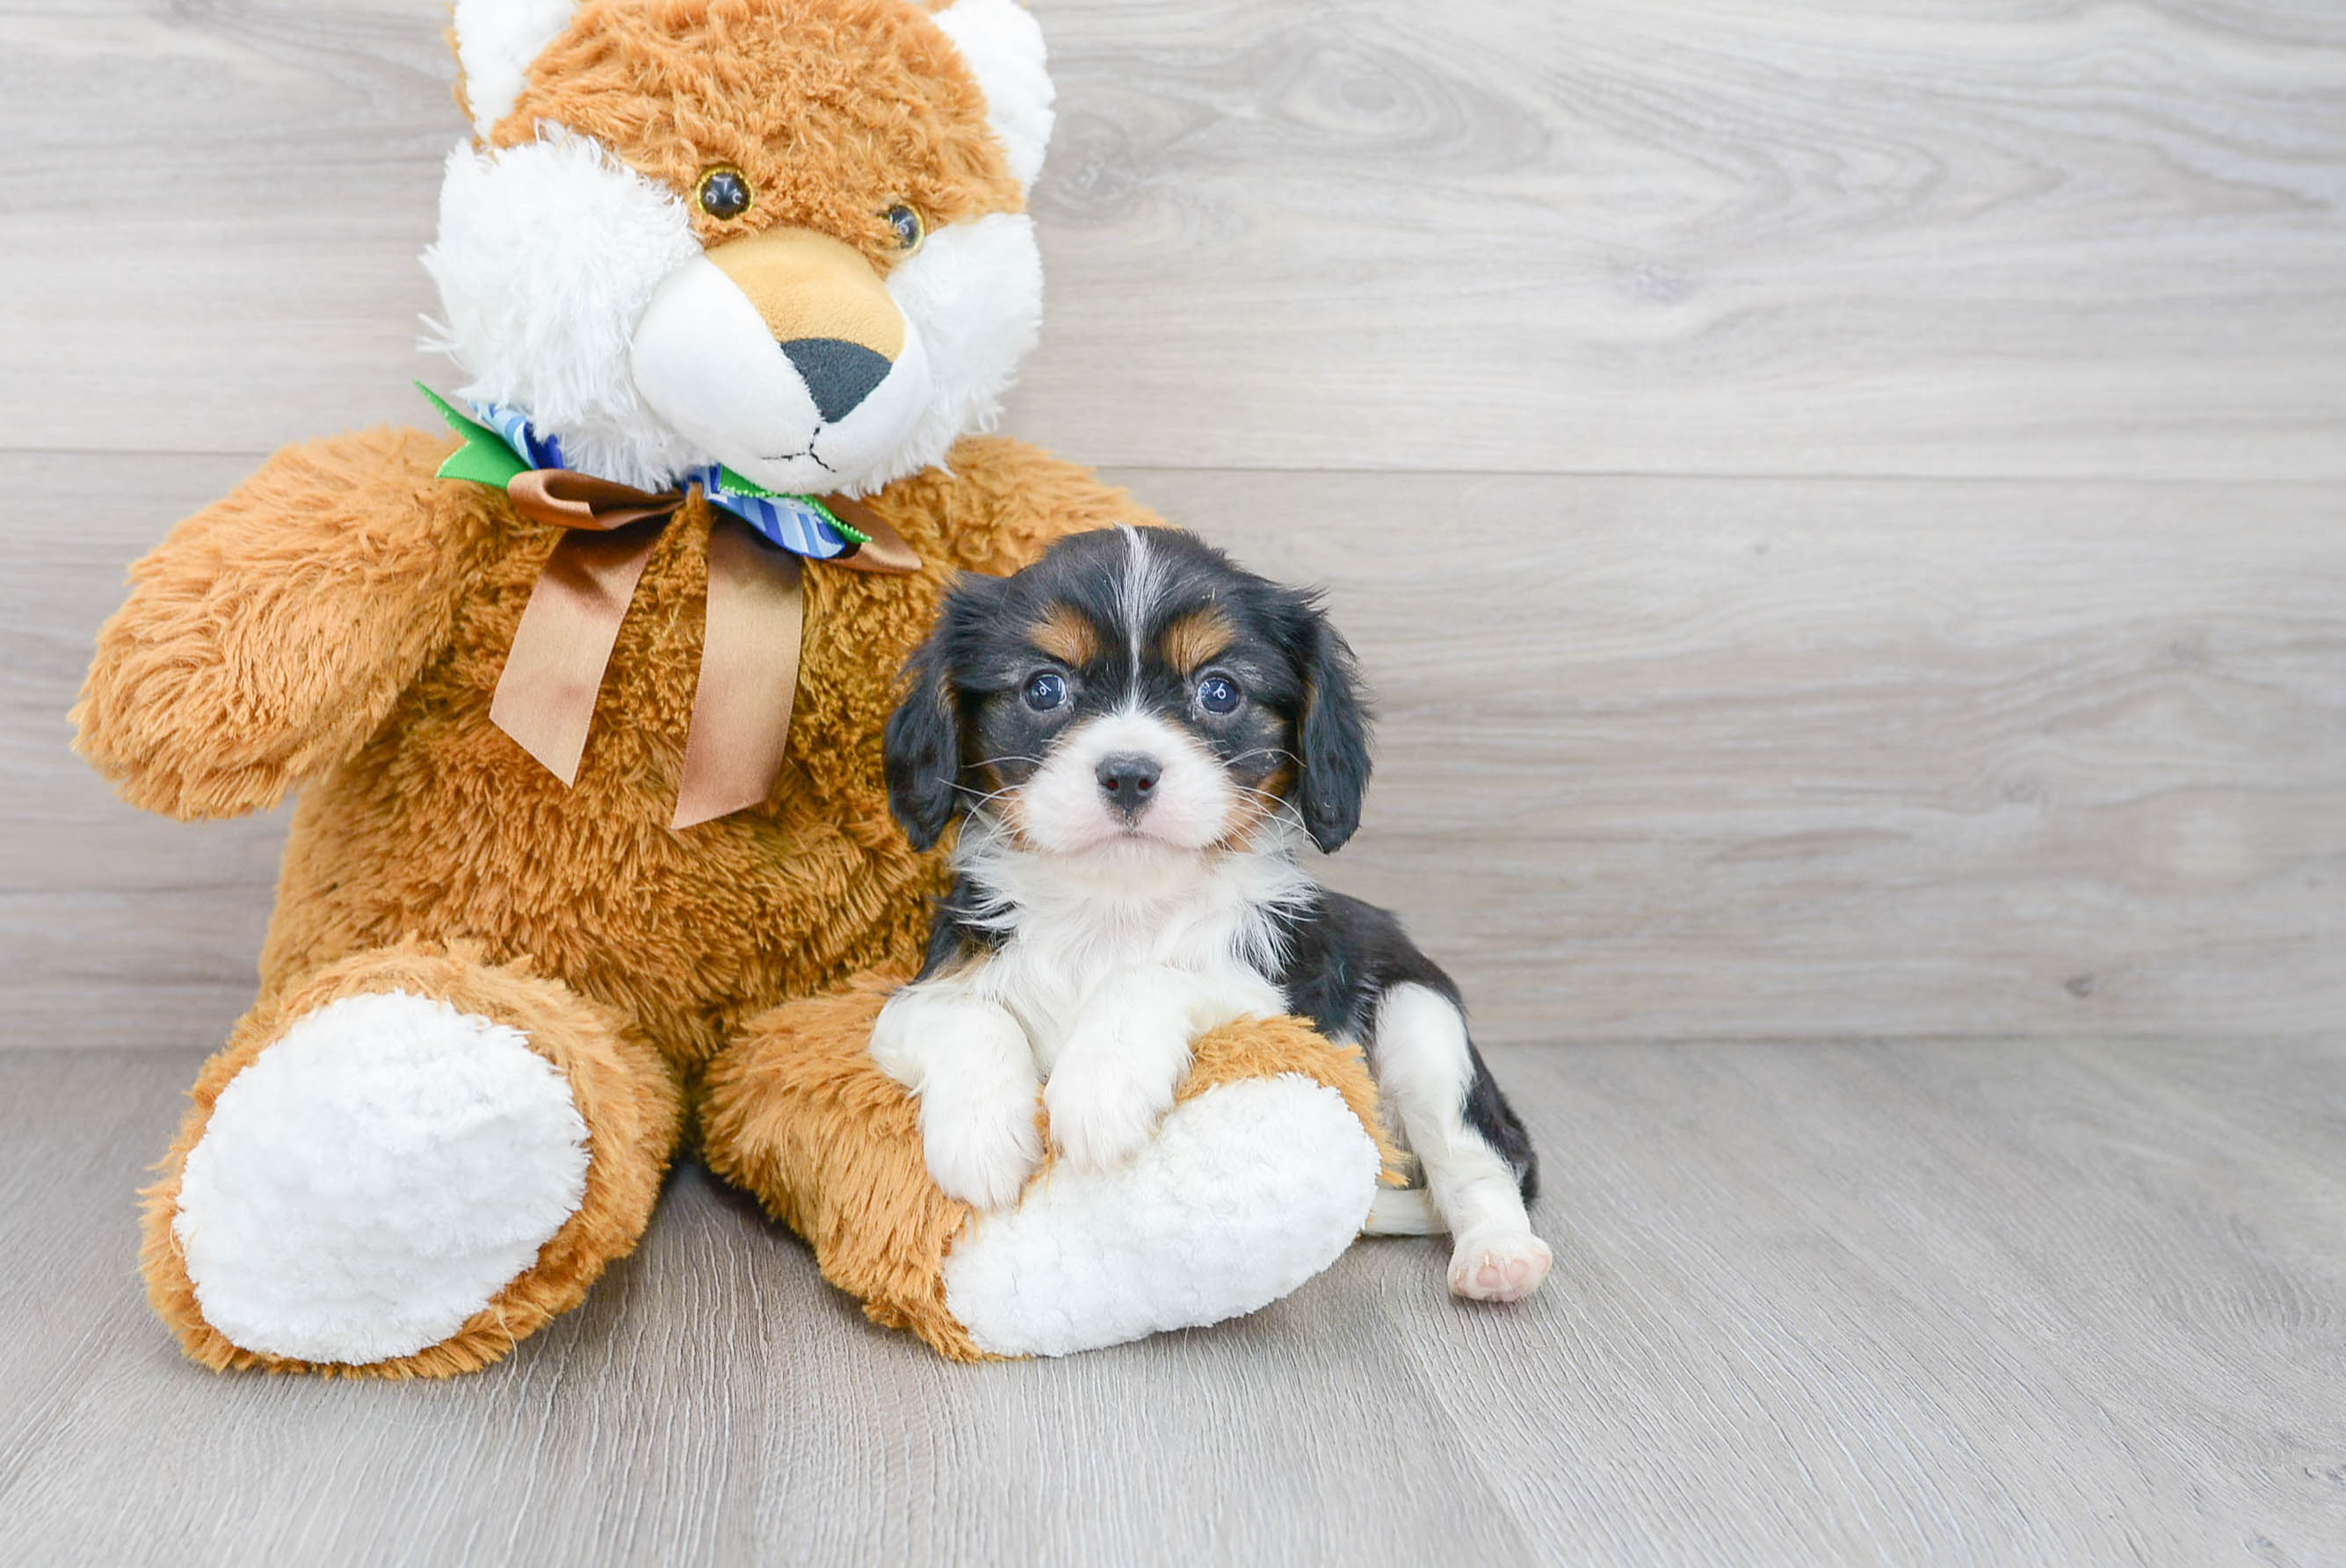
0, 1038, 2346, 1568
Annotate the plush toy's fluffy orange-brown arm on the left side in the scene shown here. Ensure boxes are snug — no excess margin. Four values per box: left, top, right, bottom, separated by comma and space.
73, 429, 493, 818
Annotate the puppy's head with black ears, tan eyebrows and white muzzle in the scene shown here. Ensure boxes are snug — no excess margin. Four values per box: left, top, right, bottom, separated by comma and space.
887, 527, 1368, 853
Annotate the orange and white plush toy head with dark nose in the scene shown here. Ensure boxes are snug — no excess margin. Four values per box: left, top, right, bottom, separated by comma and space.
424, 0, 1051, 495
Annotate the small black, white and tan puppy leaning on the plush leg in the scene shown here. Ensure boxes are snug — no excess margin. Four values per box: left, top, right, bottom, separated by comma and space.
873, 527, 1548, 1301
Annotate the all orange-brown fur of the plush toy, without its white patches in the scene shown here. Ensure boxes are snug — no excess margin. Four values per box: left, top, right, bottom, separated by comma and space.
73, 0, 1377, 1376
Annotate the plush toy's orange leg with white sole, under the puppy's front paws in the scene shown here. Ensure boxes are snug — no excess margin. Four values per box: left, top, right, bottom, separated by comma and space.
701, 979, 1389, 1360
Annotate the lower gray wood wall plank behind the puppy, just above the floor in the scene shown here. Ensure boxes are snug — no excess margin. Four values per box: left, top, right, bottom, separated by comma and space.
0, 455, 2346, 1045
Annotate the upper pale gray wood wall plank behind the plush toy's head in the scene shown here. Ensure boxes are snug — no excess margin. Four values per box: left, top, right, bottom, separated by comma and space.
0, 0, 2346, 478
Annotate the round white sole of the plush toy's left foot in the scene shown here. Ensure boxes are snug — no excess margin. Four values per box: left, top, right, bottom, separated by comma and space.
174, 992, 587, 1364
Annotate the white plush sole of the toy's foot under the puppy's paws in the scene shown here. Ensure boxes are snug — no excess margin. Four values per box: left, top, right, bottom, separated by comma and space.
945, 1073, 1379, 1355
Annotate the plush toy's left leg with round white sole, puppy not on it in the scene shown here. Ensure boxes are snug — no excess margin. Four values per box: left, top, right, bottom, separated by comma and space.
141, 943, 683, 1378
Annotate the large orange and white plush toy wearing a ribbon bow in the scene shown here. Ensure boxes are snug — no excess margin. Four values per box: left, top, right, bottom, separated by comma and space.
75, 0, 1379, 1376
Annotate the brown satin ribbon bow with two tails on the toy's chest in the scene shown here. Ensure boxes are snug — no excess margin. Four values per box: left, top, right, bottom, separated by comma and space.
488, 469, 920, 827
